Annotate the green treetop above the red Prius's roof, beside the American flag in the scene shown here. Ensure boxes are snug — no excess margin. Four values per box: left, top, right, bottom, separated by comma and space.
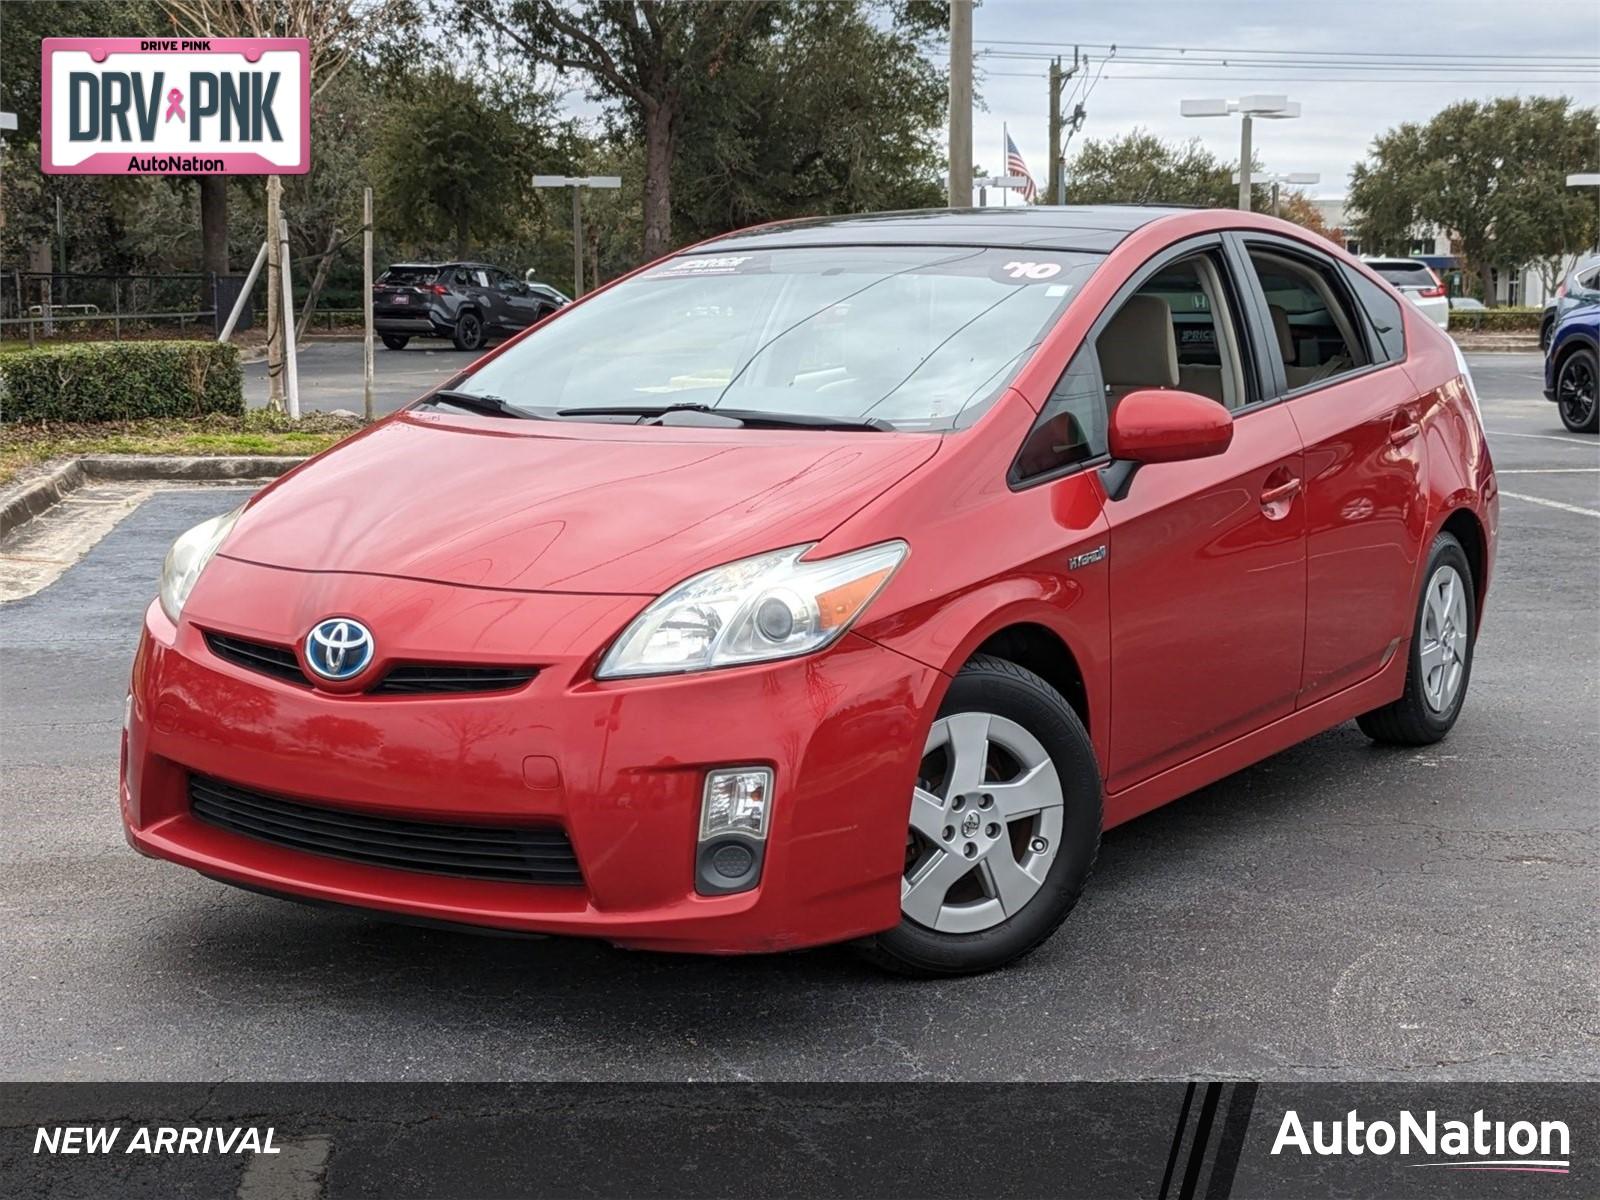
1067, 128, 1266, 211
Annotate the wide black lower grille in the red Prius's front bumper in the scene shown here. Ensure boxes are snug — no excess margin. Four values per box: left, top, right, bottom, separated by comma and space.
189, 774, 584, 885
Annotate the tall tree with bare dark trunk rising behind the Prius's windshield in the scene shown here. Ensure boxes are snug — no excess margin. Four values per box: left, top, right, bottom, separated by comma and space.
460, 0, 778, 258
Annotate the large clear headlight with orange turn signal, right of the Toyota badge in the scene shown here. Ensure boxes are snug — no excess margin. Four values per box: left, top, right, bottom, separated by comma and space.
595, 542, 907, 678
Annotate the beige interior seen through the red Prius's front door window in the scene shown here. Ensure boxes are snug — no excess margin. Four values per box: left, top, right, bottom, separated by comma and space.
1094, 254, 1248, 408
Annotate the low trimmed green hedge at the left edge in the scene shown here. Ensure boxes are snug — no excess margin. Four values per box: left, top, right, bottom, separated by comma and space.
0, 341, 245, 422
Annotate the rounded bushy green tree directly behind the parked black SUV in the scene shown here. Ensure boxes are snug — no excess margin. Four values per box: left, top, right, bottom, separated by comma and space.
373, 67, 533, 258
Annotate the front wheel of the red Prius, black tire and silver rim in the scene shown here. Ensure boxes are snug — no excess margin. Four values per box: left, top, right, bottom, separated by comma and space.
859, 656, 1101, 978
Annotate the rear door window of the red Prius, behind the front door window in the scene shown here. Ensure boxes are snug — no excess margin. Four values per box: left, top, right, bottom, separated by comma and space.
1250, 246, 1368, 392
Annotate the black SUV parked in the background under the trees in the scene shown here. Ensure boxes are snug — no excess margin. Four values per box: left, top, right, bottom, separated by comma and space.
373, 262, 566, 350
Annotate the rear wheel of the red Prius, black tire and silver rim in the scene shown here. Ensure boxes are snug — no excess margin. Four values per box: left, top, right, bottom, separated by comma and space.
1355, 533, 1478, 746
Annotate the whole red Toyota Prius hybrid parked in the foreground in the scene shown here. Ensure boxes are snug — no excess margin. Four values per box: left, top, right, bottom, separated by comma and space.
120, 206, 1498, 974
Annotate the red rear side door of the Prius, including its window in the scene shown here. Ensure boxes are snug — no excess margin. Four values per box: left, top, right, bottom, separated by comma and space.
1230, 234, 1435, 707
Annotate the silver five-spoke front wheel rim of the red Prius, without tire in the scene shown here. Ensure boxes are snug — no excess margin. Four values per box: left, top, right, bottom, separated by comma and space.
901, 712, 1062, 933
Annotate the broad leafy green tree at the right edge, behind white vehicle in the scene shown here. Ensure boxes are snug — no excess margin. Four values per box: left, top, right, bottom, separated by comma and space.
1350, 96, 1600, 304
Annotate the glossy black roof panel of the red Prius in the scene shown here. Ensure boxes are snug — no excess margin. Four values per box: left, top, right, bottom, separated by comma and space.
690, 205, 1194, 254
